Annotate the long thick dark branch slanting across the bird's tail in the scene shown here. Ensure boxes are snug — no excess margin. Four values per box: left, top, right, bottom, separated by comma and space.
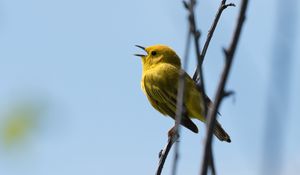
201, 0, 248, 175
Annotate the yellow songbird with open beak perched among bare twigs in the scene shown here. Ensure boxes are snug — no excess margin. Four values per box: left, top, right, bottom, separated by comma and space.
135, 45, 231, 142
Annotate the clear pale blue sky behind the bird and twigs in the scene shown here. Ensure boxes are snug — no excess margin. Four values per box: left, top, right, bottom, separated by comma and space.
0, 0, 300, 175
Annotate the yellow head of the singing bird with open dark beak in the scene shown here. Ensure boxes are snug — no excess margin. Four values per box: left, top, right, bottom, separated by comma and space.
135, 45, 181, 68
